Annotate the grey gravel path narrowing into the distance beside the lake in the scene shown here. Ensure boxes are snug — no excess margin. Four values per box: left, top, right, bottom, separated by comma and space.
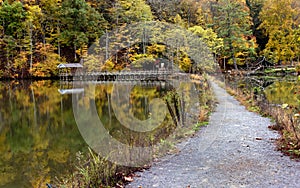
126, 83, 300, 188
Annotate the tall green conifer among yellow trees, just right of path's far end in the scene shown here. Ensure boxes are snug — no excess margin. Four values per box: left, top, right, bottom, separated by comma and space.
214, 0, 255, 69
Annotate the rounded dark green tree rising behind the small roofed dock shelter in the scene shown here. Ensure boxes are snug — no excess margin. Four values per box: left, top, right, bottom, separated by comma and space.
60, 0, 105, 61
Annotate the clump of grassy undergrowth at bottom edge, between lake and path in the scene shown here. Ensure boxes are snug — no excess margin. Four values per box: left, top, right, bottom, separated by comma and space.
55, 149, 138, 188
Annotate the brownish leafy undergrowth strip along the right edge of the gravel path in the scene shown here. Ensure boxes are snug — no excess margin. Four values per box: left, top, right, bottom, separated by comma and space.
226, 78, 300, 159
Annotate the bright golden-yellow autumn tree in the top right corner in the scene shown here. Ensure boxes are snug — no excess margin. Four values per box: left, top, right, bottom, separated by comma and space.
260, 0, 299, 63
